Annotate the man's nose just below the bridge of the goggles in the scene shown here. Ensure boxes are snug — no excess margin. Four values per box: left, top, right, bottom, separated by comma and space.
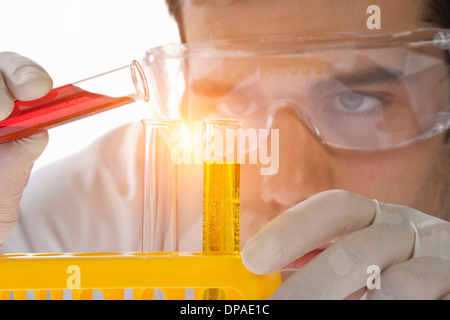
261, 106, 333, 210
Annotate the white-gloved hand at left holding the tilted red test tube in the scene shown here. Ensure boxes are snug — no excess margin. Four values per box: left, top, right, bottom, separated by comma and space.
0, 52, 53, 246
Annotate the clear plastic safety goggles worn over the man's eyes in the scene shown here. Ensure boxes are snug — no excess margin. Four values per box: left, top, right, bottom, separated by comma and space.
143, 29, 450, 150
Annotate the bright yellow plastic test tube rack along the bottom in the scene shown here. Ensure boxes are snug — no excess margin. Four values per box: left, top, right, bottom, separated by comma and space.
0, 252, 281, 300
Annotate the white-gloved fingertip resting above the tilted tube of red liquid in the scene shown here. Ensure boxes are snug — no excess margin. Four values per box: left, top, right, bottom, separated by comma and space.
0, 52, 53, 107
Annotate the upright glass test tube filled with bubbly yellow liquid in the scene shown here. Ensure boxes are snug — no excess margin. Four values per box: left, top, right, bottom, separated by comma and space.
203, 119, 243, 300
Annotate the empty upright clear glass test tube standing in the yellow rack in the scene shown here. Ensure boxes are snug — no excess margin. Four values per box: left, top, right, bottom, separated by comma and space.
141, 120, 182, 253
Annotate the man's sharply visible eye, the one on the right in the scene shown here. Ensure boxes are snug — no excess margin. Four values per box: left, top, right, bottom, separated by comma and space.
332, 91, 383, 113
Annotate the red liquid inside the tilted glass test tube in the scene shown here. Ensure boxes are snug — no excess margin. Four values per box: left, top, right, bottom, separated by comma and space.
0, 84, 134, 143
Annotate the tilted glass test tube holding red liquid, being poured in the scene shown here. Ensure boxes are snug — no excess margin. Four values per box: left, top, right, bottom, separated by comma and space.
0, 60, 149, 143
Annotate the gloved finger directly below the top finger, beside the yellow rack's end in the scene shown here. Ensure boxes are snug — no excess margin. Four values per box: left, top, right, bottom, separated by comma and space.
271, 223, 414, 299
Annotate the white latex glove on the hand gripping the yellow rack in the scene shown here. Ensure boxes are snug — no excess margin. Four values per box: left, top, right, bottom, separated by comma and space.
242, 190, 450, 299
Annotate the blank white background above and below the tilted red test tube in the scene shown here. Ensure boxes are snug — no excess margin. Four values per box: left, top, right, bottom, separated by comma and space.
0, 0, 179, 169
